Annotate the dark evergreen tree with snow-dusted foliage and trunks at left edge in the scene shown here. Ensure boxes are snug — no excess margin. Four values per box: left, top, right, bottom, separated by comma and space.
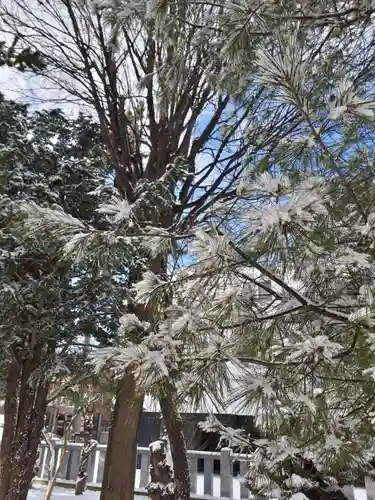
0, 96, 127, 499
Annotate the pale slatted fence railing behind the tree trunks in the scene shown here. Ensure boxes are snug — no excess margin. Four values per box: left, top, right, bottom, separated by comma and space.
37, 441, 375, 500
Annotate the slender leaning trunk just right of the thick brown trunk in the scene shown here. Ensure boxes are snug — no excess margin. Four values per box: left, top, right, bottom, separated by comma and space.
159, 396, 190, 500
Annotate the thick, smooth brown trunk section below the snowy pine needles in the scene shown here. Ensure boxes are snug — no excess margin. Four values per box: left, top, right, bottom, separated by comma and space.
100, 375, 143, 500
